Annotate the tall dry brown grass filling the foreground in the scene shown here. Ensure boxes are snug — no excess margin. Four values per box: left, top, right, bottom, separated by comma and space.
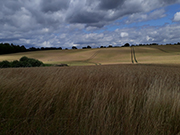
0, 65, 180, 135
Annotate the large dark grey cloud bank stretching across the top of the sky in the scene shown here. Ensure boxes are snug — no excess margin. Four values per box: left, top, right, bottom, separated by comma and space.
0, 0, 178, 27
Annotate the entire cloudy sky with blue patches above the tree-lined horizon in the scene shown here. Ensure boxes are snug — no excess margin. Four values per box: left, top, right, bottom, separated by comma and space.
0, 0, 180, 48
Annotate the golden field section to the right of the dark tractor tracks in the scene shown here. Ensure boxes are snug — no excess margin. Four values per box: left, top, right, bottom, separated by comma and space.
135, 45, 180, 64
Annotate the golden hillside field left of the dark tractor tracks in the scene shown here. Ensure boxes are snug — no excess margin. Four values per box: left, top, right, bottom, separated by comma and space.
0, 48, 130, 66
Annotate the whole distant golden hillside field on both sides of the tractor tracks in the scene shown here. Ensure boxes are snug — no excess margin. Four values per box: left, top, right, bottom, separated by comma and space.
0, 45, 180, 66
